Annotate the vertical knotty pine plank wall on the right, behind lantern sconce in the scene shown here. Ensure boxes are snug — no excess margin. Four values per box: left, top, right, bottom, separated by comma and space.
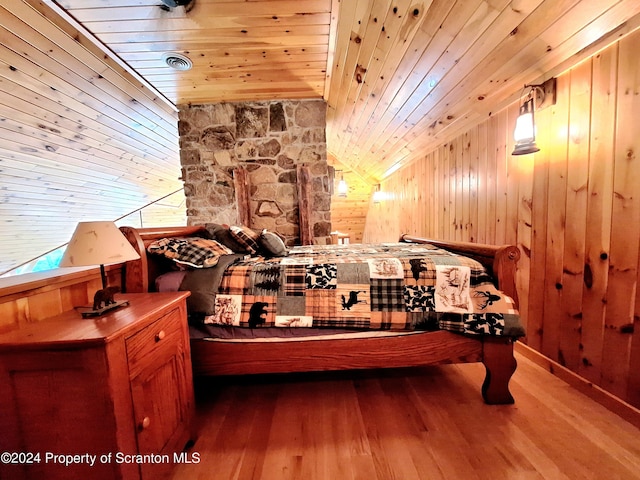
364, 32, 640, 407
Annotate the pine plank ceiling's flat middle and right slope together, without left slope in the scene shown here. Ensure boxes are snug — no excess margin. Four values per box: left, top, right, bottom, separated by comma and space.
59, 0, 640, 184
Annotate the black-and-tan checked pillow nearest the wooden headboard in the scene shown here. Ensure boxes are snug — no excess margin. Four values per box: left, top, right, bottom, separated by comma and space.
147, 237, 233, 268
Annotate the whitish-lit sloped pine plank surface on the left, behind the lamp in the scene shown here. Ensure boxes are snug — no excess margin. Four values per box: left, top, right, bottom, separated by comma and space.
0, 0, 185, 274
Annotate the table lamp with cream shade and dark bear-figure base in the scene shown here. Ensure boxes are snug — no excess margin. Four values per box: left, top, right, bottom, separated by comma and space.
60, 222, 140, 317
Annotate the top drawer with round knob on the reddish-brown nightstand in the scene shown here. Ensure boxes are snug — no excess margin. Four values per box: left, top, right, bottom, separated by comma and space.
125, 309, 185, 378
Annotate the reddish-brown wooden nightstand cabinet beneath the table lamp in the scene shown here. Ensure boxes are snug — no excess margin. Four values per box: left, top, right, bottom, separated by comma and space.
0, 292, 194, 480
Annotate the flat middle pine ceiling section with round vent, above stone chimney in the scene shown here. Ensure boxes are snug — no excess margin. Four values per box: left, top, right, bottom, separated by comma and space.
58, 0, 331, 105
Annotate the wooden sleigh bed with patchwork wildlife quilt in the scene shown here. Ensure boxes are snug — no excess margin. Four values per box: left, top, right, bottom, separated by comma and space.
121, 226, 524, 404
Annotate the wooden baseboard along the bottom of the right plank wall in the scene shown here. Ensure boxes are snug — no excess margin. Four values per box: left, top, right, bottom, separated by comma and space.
514, 342, 640, 428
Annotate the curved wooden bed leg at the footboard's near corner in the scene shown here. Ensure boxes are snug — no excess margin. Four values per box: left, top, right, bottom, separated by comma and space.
482, 338, 517, 405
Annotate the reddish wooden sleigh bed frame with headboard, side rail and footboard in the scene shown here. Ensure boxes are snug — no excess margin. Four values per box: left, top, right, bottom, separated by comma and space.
120, 227, 520, 404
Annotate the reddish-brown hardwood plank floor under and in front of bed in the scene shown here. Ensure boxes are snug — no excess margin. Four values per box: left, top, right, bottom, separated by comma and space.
173, 355, 640, 480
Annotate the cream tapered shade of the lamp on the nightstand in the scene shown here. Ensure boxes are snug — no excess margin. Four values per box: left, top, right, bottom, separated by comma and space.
60, 222, 140, 267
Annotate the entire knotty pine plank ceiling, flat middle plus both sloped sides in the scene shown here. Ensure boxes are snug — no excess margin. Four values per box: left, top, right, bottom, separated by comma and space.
0, 0, 640, 273
